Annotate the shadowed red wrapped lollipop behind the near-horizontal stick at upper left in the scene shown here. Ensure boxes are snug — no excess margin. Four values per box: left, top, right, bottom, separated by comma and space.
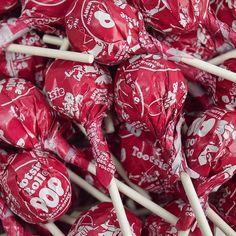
0, 21, 46, 87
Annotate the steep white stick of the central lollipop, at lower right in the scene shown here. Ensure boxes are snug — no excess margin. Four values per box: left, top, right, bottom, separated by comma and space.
180, 172, 213, 236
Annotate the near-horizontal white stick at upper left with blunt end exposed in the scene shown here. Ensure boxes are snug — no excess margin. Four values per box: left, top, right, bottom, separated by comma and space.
5, 44, 94, 63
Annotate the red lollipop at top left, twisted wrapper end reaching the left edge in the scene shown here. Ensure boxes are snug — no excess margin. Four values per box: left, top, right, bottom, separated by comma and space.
0, 0, 73, 48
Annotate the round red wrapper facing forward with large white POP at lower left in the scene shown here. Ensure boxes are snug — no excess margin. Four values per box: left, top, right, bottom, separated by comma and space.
1, 151, 71, 224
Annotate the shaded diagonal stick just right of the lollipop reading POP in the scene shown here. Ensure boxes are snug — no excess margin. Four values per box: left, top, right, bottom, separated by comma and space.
67, 169, 111, 202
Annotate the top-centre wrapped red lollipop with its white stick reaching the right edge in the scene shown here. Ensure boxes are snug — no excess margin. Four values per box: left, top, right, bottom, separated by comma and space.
66, 0, 235, 81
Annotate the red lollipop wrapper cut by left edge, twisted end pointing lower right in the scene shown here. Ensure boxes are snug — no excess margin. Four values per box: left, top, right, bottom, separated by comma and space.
0, 78, 88, 169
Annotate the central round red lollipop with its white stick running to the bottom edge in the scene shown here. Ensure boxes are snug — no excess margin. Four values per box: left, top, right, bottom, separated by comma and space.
115, 55, 214, 235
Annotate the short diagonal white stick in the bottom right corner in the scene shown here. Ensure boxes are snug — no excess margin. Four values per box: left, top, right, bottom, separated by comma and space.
206, 207, 236, 236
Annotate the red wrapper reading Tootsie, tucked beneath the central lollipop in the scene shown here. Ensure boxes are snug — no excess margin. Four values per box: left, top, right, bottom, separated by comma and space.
119, 121, 175, 201
